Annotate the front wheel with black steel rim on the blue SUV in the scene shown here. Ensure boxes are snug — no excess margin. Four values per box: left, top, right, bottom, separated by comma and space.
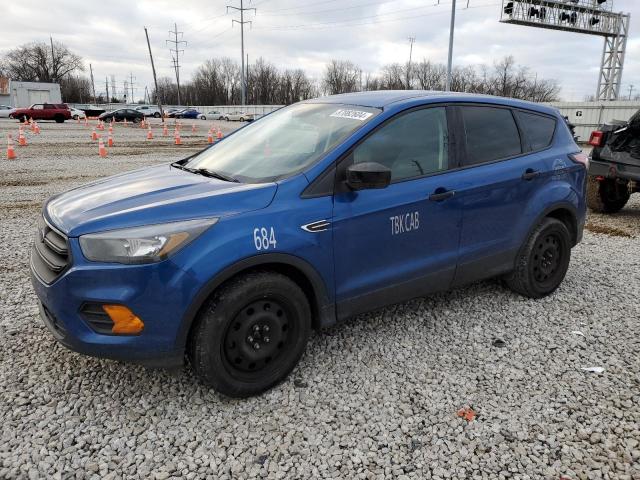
189, 272, 311, 398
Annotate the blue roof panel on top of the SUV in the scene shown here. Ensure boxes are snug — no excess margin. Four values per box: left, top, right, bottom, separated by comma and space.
307, 90, 554, 113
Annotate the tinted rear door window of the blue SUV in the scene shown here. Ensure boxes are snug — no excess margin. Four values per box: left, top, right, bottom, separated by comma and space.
460, 106, 522, 165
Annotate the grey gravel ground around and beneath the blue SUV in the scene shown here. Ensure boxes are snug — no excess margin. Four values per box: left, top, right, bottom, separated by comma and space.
0, 117, 640, 479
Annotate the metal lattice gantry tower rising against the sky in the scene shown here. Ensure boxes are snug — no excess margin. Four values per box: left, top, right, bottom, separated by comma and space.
500, 0, 631, 100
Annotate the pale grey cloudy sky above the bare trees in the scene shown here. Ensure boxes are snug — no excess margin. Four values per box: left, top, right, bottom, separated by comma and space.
0, 0, 640, 100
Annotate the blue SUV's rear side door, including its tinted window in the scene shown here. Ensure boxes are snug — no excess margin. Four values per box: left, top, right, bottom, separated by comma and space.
454, 105, 555, 285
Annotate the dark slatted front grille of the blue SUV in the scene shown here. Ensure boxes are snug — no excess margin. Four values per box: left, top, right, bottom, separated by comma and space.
31, 218, 70, 283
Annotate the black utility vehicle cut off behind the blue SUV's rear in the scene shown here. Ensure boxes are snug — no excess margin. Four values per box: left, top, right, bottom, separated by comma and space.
587, 111, 640, 213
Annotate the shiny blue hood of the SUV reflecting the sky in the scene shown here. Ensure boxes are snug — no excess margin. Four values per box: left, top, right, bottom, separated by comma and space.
45, 165, 277, 237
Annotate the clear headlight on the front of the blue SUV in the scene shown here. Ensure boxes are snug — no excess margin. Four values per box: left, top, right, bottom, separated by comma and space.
80, 218, 218, 264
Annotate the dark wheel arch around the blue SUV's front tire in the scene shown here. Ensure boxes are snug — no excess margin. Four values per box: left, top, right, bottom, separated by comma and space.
177, 253, 336, 350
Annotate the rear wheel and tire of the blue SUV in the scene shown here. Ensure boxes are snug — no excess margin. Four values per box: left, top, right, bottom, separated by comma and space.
505, 217, 572, 298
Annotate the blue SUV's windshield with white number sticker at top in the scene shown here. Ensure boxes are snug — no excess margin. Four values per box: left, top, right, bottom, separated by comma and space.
185, 103, 380, 183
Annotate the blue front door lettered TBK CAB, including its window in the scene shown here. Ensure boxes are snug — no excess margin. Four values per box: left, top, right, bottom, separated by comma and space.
333, 106, 461, 318
